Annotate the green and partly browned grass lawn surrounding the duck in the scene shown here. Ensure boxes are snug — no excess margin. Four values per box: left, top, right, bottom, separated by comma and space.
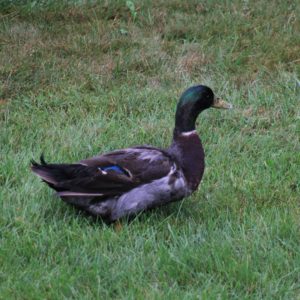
0, 0, 300, 299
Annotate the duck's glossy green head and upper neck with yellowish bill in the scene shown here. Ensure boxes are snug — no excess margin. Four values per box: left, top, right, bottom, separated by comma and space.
175, 85, 232, 133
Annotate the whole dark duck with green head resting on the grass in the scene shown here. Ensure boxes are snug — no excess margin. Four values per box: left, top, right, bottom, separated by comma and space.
31, 85, 232, 223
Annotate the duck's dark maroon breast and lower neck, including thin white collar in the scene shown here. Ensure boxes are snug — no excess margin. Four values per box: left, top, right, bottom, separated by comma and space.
169, 128, 204, 191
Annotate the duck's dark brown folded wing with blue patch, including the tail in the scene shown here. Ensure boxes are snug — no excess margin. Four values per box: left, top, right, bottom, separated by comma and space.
32, 146, 174, 197
